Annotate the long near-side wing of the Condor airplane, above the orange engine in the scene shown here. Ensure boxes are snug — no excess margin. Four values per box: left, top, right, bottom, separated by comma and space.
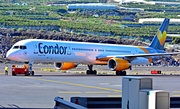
96, 52, 180, 61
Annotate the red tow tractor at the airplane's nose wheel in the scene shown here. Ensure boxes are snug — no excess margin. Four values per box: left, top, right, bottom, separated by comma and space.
12, 64, 34, 76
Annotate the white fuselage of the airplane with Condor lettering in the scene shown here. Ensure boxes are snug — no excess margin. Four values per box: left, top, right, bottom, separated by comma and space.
7, 39, 156, 64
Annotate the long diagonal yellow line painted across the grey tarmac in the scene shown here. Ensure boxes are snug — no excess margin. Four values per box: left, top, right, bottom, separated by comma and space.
22, 77, 121, 92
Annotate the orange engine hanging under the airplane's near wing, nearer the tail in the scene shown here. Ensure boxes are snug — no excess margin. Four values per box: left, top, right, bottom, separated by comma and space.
107, 58, 131, 71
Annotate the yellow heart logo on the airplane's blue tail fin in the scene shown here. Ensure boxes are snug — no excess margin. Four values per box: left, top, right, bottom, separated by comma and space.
157, 30, 167, 46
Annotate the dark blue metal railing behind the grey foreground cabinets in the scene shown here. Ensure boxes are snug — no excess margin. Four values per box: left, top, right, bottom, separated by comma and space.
54, 97, 180, 109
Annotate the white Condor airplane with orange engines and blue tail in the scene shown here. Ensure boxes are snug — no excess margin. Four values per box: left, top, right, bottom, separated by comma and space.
6, 18, 180, 76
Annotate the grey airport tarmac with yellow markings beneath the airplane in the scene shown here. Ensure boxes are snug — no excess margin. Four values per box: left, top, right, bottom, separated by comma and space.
0, 64, 180, 108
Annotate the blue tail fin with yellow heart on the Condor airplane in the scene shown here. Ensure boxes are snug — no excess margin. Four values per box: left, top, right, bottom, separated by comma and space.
149, 18, 170, 50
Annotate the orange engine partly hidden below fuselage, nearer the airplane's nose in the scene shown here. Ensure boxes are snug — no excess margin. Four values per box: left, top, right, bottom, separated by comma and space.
54, 62, 77, 70
